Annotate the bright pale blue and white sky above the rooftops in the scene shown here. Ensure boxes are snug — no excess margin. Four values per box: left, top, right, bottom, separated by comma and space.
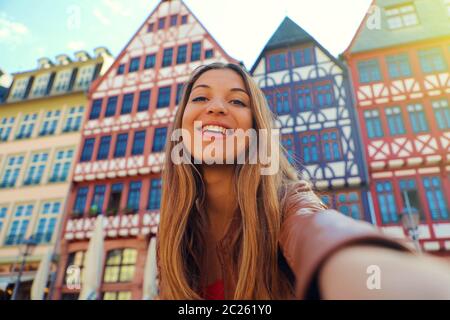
0, 0, 371, 73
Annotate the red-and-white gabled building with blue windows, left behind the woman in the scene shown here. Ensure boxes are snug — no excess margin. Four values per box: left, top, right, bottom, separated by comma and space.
53, 0, 237, 299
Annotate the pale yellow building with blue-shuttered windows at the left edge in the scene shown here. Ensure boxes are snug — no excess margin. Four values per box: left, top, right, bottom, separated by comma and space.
0, 48, 112, 299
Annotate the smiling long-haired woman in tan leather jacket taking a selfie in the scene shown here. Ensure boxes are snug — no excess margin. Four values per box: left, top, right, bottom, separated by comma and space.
158, 63, 450, 300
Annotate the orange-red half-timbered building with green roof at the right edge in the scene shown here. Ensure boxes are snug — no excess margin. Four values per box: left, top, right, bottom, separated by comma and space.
345, 0, 450, 254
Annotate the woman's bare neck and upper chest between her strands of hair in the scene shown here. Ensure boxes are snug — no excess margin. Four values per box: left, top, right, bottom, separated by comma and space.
202, 165, 237, 239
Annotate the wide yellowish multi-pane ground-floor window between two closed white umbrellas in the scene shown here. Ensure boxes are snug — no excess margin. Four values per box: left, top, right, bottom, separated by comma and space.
103, 249, 137, 283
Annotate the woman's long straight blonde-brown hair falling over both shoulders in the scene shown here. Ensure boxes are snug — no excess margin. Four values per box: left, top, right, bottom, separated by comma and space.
158, 63, 323, 300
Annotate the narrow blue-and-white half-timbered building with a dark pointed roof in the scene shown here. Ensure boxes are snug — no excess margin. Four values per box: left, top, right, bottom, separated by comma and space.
251, 18, 374, 222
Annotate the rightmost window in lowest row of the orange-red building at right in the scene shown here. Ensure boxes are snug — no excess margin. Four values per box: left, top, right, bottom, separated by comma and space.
422, 177, 449, 221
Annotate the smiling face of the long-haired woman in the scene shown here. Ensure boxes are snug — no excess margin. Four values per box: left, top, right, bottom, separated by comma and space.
182, 69, 253, 164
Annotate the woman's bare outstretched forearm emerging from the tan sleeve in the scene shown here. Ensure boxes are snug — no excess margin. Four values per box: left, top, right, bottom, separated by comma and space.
319, 245, 450, 300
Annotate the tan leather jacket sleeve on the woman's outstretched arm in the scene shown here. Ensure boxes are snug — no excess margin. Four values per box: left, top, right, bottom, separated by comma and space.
279, 210, 413, 299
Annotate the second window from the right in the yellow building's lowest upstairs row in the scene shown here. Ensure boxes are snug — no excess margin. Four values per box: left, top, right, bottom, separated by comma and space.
5, 204, 33, 246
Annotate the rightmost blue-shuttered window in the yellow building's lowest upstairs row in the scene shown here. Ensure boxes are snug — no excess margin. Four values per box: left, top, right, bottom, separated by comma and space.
35, 202, 61, 243
